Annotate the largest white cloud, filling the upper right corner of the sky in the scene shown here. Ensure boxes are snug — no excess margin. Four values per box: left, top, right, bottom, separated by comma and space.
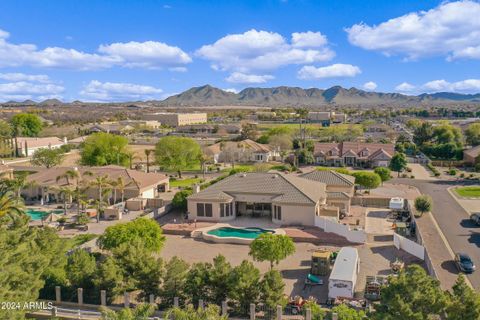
346, 0, 480, 59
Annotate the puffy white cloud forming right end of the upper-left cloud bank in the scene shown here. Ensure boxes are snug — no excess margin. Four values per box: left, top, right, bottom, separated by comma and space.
98, 41, 192, 68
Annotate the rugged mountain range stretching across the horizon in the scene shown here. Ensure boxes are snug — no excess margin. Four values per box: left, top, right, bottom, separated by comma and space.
3, 85, 480, 107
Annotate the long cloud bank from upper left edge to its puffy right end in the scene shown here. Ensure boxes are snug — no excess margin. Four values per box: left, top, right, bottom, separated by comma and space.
0, 30, 192, 70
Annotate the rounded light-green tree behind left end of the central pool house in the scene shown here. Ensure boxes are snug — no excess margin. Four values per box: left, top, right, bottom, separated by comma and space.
155, 136, 202, 178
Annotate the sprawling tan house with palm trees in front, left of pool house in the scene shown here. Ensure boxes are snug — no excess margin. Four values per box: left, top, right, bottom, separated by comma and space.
22, 166, 169, 203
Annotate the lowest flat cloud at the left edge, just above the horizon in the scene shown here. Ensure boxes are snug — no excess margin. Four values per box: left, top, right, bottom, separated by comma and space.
0, 81, 65, 101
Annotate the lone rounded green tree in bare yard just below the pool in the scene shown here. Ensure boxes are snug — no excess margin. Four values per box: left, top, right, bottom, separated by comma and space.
249, 233, 295, 269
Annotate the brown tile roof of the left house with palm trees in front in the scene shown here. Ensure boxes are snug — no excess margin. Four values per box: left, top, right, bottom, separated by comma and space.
27, 166, 168, 190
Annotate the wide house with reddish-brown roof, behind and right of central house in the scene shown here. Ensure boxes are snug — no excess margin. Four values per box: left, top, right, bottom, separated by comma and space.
313, 142, 395, 168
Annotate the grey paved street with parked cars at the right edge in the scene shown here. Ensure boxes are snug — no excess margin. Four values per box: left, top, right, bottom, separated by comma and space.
395, 179, 480, 290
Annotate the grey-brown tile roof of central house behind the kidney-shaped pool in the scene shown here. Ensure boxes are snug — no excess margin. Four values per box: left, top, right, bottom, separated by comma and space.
188, 173, 326, 204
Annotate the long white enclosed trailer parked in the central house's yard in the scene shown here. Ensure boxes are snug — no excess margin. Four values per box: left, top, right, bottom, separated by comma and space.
328, 247, 360, 298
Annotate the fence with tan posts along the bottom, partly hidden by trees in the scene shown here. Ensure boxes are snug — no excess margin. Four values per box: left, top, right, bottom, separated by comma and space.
44, 286, 348, 320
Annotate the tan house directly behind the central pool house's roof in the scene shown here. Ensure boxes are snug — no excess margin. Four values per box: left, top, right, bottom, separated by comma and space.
204, 139, 280, 163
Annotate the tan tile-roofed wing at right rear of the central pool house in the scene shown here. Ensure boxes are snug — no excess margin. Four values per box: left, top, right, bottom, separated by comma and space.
300, 170, 355, 213
